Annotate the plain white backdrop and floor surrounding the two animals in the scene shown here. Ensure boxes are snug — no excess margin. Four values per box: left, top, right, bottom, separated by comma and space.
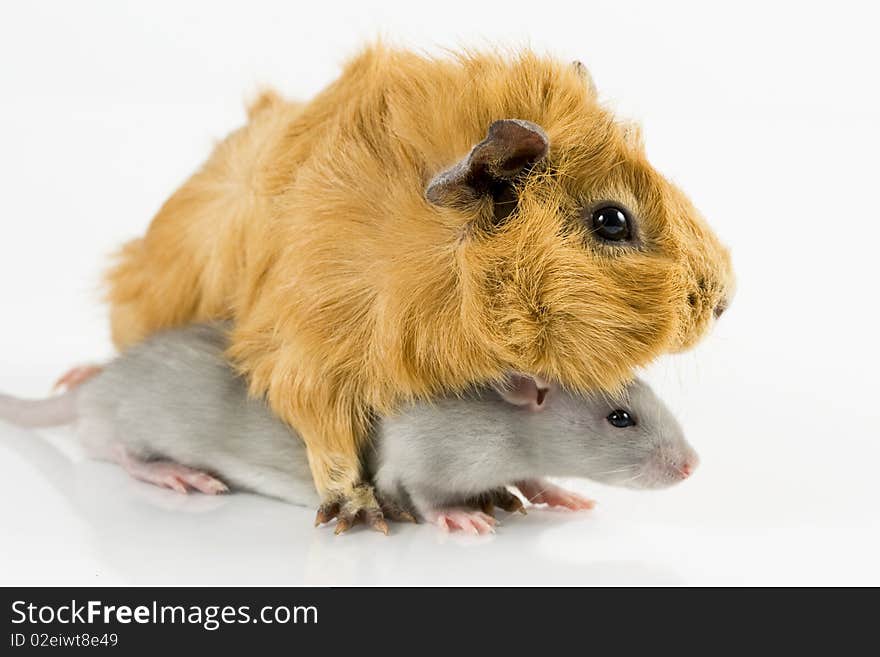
0, 0, 880, 585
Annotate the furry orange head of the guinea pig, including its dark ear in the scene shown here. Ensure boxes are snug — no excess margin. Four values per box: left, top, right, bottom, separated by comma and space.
426, 56, 733, 390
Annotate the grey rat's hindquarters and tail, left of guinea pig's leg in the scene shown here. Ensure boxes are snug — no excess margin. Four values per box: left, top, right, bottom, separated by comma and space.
0, 325, 318, 504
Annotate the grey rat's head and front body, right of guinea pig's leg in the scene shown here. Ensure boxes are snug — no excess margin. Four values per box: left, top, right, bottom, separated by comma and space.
372, 380, 698, 532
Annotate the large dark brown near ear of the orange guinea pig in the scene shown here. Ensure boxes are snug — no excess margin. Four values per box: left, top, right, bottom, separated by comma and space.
425, 119, 549, 220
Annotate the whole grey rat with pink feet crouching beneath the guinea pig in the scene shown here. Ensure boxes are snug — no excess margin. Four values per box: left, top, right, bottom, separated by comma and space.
0, 324, 698, 533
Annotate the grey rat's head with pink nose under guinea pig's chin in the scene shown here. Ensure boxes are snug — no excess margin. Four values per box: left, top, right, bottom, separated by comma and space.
530, 380, 699, 488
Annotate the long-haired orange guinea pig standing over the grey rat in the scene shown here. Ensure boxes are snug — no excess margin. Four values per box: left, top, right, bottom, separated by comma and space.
107, 45, 733, 525
